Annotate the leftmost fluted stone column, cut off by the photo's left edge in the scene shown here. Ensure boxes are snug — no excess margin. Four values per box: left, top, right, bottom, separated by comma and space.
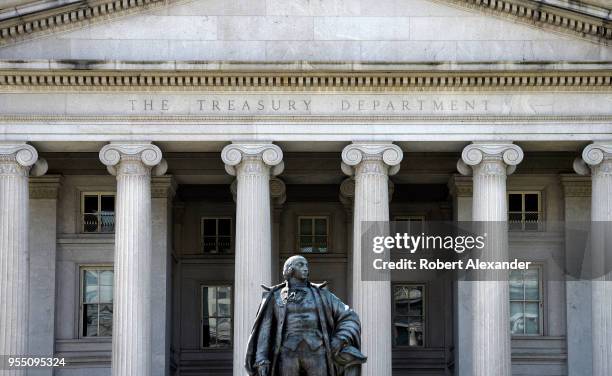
0, 142, 46, 376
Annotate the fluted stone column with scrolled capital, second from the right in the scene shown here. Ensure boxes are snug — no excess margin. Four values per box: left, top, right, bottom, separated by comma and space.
457, 142, 523, 376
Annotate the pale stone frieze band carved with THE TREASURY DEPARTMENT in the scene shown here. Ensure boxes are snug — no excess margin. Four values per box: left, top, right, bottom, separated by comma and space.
0, 92, 612, 118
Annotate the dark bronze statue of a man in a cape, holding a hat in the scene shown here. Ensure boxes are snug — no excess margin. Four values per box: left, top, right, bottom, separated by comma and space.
245, 256, 366, 376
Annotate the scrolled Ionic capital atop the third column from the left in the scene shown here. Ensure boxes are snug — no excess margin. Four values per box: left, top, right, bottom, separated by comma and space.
221, 142, 285, 176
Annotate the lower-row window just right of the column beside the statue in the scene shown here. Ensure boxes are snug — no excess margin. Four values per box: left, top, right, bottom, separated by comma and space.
393, 285, 425, 347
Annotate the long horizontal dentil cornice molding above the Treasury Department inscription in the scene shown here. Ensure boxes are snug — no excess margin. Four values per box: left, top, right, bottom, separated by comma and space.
0, 69, 612, 92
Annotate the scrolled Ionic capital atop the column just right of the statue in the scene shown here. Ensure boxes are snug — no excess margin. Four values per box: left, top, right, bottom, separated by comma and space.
342, 142, 404, 176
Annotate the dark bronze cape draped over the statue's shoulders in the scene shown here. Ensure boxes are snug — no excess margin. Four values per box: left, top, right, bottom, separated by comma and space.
245, 282, 367, 376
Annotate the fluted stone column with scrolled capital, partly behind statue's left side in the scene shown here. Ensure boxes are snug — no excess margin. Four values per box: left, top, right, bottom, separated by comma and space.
221, 142, 284, 376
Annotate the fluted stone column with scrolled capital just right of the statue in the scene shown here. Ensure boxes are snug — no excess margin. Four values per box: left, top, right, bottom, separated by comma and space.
342, 142, 403, 376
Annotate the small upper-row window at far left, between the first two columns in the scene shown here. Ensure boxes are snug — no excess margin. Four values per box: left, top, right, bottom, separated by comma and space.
81, 192, 115, 233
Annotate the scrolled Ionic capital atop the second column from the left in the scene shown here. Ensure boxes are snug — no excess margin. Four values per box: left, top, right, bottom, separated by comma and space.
100, 142, 168, 176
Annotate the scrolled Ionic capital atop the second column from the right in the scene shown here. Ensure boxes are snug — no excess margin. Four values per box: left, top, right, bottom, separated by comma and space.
457, 142, 525, 176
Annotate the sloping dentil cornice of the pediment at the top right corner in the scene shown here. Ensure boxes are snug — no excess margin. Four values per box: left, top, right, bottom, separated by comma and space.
437, 0, 612, 45
